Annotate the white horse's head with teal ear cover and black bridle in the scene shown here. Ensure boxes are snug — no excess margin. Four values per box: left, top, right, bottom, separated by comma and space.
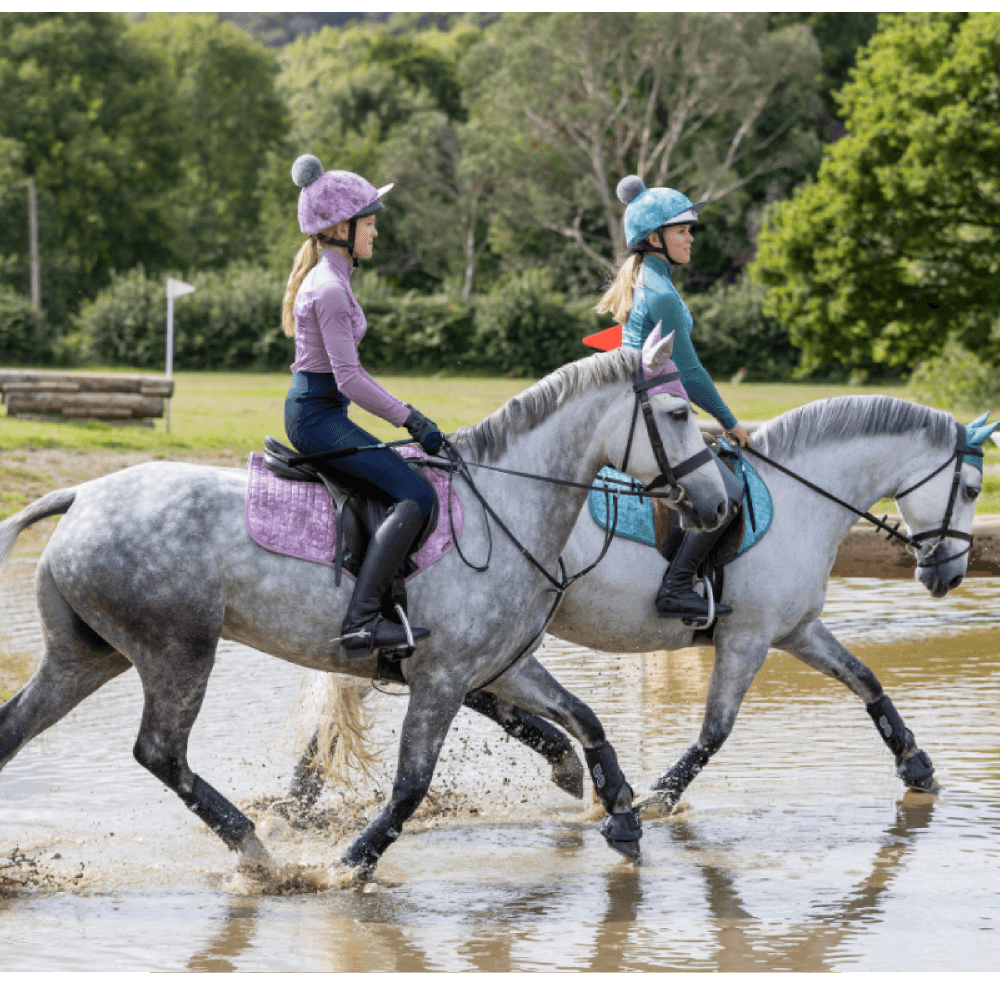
896, 413, 998, 597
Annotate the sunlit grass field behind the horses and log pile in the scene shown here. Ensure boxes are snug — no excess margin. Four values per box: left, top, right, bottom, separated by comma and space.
0, 372, 1000, 516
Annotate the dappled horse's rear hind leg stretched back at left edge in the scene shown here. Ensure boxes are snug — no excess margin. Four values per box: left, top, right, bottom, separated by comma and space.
0, 563, 132, 768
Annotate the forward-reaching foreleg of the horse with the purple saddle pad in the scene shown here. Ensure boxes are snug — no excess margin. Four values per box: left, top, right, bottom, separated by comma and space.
489, 656, 642, 861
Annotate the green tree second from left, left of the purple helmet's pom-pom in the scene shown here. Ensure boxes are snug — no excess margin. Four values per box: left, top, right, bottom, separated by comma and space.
135, 14, 288, 269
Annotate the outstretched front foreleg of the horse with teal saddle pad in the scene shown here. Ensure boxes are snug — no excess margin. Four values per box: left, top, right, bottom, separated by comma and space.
775, 619, 937, 792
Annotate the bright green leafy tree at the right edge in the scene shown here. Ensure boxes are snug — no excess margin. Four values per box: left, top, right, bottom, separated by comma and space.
753, 13, 1000, 370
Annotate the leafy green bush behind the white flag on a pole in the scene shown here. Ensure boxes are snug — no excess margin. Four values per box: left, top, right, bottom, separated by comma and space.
76, 265, 295, 371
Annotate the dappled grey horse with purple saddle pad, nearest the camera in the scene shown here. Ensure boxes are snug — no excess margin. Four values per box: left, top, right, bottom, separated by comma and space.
0, 338, 726, 870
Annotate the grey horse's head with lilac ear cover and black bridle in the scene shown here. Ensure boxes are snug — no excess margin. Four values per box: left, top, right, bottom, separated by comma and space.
608, 323, 728, 531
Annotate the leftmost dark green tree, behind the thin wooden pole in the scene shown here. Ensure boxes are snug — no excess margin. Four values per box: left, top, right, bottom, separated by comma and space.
0, 13, 180, 321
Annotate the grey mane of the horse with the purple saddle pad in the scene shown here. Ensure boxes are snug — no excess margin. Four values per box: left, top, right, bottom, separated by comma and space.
448, 347, 641, 461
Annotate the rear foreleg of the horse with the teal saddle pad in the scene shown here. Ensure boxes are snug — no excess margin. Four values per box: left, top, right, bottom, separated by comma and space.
639, 634, 767, 812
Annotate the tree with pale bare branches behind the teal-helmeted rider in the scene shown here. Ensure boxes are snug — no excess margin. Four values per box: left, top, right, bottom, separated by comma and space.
464, 12, 819, 286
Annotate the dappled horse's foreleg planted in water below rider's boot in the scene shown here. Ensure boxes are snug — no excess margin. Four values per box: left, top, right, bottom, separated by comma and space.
340, 683, 465, 872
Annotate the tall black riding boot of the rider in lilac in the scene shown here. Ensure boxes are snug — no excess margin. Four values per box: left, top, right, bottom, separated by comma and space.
340, 500, 430, 660
